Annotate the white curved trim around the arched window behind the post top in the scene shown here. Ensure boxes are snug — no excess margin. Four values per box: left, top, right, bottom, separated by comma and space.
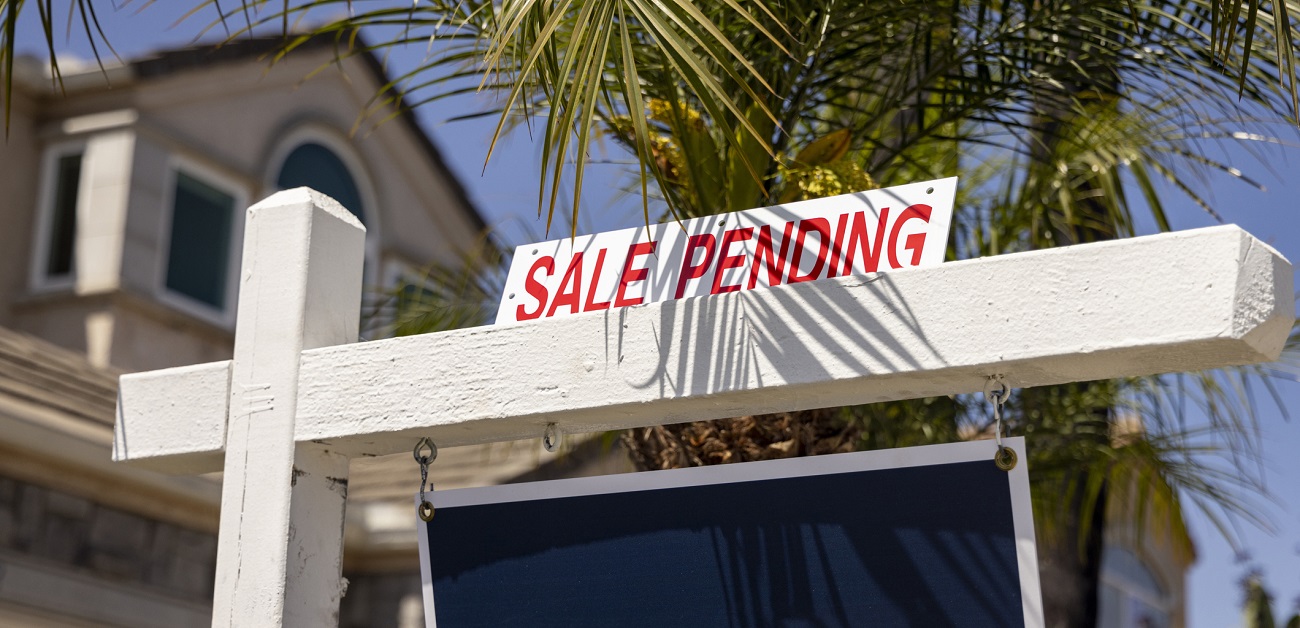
263, 122, 382, 287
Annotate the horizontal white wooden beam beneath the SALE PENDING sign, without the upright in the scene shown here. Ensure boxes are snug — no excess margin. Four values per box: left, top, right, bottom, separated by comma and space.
121, 226, 1295, 471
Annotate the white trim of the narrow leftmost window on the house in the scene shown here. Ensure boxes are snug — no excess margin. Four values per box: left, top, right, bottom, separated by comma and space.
27, 139, 88, 293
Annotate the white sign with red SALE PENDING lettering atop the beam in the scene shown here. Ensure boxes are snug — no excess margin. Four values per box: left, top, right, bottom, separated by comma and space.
497, 177, 957, 322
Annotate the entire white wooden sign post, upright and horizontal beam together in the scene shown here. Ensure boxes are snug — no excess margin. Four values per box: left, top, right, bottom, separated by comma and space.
113, 189, 1295, 627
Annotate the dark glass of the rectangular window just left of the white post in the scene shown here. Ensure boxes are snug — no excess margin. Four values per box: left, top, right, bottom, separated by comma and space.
166, 172, 235, 309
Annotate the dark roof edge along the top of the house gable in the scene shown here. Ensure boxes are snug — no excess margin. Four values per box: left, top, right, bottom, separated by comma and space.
95, 35, 486, 230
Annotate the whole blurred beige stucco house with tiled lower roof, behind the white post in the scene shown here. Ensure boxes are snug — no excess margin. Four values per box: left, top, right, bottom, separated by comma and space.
0, 38, 624, 627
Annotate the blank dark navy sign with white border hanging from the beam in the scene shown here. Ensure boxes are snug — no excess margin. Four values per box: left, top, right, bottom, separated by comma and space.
420, 438, 1043, 628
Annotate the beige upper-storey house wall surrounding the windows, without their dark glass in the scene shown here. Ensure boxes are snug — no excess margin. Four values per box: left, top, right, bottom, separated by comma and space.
0, 48, 478, 371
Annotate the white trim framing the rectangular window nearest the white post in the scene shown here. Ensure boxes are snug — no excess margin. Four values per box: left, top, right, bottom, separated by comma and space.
153, 155, 248, 329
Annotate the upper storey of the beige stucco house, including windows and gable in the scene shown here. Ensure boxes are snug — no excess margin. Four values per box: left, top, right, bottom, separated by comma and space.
0, 38, 484, 371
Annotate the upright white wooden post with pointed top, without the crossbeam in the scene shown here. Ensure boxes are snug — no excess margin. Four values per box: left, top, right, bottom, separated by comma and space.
212, 187, 365, 627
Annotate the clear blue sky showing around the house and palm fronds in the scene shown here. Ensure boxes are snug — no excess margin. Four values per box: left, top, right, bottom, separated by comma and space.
12, 0, 1300, 628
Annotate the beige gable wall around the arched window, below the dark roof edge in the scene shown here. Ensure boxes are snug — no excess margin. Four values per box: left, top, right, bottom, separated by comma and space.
125, 53, 477, 270
